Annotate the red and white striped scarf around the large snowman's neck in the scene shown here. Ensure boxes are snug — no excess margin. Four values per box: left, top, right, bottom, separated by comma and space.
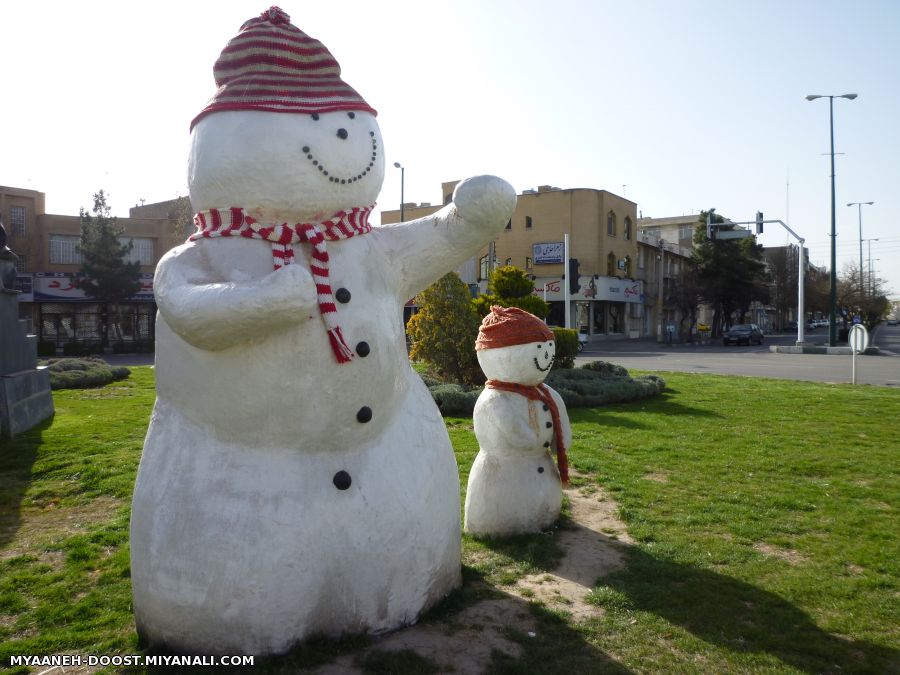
188, 204, 375, 363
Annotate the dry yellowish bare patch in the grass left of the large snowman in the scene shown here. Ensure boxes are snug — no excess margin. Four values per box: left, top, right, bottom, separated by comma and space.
0, 497, 125, 565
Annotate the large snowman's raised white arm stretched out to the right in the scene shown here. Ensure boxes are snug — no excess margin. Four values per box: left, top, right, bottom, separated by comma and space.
376, 176, 516, 299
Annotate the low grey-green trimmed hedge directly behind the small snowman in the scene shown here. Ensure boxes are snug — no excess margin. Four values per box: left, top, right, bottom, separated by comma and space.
421, 360, 666, 416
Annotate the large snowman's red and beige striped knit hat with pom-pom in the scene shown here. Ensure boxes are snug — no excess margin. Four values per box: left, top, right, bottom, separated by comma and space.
191, 6, 377, 129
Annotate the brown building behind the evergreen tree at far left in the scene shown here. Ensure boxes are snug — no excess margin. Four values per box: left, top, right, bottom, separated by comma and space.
0, 186, 183, 353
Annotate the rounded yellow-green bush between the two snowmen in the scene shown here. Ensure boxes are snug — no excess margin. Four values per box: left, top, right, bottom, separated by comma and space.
406, 272, 484, 384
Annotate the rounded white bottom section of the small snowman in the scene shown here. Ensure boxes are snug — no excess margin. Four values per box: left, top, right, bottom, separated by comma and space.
465, 450, 562, 537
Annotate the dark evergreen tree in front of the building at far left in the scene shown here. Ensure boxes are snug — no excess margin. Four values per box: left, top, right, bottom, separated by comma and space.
75, 190, 141, 347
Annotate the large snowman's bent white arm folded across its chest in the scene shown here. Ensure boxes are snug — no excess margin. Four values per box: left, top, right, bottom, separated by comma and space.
153, 245, 318, 351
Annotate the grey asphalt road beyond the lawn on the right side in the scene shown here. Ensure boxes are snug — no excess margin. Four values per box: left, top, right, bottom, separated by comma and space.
576, 324, 900, 388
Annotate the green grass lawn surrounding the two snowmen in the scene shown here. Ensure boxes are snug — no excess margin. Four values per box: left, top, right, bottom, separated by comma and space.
0, 368, 900, 673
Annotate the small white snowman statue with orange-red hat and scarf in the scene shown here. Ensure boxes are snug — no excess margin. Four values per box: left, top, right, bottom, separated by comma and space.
465, 306, 572, 537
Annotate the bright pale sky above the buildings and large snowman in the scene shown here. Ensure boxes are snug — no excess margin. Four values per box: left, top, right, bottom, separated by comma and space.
0, 0, 900, 295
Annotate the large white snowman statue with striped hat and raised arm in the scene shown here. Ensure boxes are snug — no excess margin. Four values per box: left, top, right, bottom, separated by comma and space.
131, 7, 515, 654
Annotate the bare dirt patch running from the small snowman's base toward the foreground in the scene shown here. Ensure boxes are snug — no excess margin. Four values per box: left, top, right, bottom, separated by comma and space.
314, 485, 633, 675
